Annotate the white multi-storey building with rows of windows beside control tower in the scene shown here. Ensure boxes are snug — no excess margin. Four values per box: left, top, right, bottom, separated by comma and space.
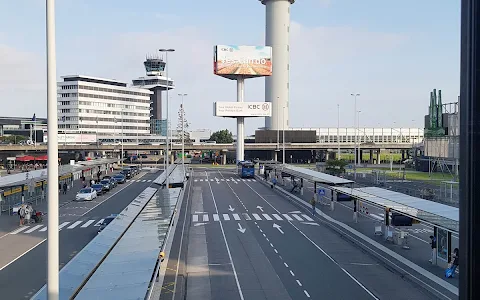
58, 75, 154, 140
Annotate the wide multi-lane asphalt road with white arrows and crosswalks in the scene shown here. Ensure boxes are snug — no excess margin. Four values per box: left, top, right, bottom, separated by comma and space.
172, 169, 434, 300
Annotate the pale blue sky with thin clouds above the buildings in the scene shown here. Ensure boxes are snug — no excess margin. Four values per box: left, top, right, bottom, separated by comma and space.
0, 0, 460, 134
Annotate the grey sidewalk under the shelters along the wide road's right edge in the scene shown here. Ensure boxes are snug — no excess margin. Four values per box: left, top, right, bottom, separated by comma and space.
257, 177, 459, 295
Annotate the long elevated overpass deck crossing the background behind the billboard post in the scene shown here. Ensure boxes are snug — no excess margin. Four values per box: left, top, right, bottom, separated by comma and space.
0, 143, 412, 153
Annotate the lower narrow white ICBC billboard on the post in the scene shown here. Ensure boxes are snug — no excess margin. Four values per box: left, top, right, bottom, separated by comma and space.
213, 102, 272, 117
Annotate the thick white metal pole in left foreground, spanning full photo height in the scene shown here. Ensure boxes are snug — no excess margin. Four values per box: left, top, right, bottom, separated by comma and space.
46, 0, 59, 300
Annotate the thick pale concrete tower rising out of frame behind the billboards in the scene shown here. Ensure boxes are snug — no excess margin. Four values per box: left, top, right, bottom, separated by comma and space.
259, 0, 295, 130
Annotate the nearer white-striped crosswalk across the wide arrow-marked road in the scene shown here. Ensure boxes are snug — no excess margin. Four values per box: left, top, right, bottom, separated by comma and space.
192, 213, 315, 223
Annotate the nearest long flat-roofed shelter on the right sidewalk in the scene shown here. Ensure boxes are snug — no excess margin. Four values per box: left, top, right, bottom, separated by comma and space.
332, 187, 459, 263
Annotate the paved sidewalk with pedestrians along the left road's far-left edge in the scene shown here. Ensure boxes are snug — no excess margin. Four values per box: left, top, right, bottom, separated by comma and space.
0, 176, 91, 236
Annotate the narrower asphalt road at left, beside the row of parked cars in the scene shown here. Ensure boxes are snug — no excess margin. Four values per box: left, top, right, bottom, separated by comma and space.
0, 173, 159, 300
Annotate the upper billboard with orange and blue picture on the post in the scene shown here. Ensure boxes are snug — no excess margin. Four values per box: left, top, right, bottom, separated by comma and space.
213, 45, 272, 79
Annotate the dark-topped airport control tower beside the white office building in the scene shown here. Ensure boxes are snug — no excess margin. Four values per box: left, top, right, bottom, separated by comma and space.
132, 56, 175, 122
